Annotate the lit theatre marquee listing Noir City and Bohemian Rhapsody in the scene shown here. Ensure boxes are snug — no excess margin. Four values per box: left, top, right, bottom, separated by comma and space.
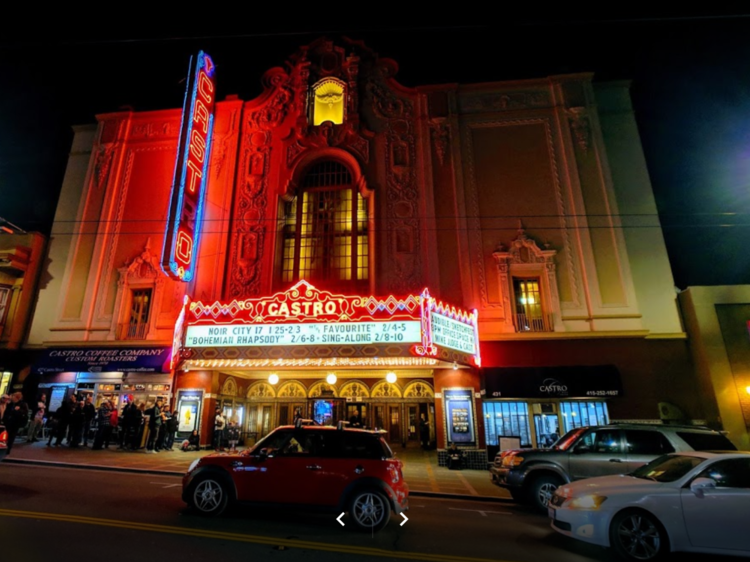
175, 281, 480, 368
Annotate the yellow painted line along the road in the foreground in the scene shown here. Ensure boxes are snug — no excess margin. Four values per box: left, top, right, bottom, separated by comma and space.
0, 509, 504, 562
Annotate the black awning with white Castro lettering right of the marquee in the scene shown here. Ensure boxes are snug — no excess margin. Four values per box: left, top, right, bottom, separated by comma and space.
483, 365, 622, 399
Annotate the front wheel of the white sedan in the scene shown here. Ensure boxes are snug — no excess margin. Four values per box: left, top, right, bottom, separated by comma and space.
609, 510, 669, 561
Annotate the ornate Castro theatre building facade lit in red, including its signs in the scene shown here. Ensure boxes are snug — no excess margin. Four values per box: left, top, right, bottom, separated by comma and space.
27, 38, 712, 460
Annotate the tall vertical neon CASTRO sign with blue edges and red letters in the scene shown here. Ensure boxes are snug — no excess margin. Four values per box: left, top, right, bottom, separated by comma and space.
161, 51, 216, 282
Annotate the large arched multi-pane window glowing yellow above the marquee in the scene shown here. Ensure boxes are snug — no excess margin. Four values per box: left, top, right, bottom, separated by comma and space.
281, 161, 369, 290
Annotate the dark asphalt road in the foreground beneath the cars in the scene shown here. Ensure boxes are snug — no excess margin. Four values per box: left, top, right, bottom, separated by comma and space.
0, 464, 738, 562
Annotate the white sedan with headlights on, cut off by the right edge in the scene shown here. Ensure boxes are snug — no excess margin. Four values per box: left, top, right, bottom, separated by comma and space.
549, 451, 750, 560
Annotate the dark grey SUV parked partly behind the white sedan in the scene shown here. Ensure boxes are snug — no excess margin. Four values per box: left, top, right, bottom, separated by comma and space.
490, 424, 737, 512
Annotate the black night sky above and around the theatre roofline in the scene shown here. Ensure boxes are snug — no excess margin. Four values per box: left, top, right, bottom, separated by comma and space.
0, 13, 750, 288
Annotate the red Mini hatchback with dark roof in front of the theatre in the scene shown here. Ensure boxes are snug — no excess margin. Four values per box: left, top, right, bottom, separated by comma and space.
182, 420, 409, 531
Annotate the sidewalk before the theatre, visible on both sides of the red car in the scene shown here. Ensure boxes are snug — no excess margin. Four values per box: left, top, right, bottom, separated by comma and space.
3, 441, 510, 501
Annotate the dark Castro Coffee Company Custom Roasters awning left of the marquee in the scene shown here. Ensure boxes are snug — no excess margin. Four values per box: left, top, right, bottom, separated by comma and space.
32, 347, 172, 374
